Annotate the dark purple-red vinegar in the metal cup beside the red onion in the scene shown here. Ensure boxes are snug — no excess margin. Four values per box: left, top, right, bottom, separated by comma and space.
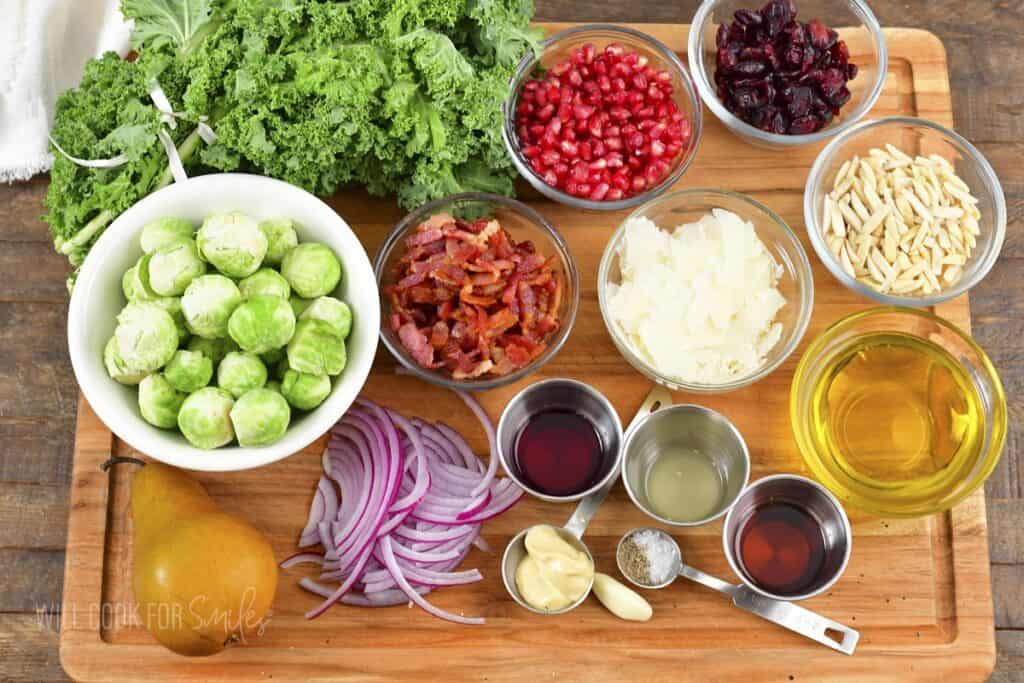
515, 410, 604, 496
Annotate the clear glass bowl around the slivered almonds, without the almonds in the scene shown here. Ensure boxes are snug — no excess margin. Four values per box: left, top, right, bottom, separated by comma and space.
804, 117, 1007, 306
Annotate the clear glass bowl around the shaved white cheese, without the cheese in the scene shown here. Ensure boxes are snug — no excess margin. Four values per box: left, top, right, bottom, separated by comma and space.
597, 188, 814, 393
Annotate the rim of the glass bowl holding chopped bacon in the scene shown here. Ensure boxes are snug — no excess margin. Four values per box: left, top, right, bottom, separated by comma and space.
373, 193, 580, 391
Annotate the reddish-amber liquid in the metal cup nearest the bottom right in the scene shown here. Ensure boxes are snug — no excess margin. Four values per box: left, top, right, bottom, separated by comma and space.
739, 502, 826, 596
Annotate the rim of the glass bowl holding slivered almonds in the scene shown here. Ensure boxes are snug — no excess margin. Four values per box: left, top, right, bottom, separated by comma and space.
804, 116, 1007, 308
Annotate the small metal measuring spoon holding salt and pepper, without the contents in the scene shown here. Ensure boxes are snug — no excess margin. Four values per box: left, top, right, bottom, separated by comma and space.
615, 528, 860, 654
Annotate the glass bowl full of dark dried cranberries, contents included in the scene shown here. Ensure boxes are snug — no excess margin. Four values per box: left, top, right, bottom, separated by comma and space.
688, 0, 888, 148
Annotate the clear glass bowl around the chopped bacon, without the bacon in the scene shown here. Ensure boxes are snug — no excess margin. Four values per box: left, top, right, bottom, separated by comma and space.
374, 193, 580, 391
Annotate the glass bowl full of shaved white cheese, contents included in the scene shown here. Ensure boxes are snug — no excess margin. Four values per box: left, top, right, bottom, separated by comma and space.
598, 188, 814, 393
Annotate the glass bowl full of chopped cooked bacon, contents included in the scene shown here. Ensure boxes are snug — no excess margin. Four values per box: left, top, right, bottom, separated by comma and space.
374, 193, 580, 390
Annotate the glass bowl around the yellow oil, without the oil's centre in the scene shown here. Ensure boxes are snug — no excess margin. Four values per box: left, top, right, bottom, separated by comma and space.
790, 306, 1007, 517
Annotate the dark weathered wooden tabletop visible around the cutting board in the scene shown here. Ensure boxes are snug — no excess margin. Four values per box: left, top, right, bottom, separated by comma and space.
0, 0, 1024, 683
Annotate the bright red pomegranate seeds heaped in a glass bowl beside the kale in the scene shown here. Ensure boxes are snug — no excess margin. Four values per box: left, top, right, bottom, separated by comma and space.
515, 43, 692, 202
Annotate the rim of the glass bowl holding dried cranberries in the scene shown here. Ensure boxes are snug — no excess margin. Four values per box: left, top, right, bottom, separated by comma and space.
686, 0, 889, 147
